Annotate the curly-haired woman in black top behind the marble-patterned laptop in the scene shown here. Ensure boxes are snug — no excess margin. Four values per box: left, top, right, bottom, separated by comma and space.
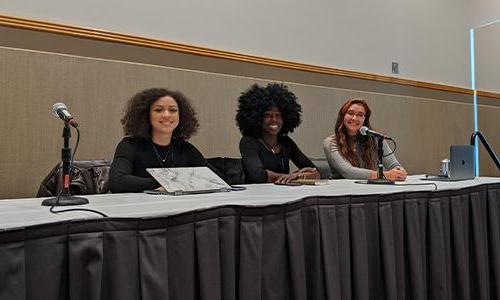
109, 88, 207, 193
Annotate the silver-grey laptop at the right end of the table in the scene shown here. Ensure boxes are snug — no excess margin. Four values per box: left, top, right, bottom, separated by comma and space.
422, 145, 474, 181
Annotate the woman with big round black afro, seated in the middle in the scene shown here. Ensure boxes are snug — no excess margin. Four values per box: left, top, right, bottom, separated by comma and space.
236, 83, 319, 183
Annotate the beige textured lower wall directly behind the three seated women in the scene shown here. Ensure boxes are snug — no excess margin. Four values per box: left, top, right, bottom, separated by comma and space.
0, 43, 500, 198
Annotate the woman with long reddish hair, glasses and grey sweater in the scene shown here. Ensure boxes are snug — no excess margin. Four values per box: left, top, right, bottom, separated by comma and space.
323, 98, 407, 181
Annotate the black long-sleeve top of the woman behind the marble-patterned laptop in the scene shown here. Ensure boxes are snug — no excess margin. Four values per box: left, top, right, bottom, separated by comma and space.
109, 137, 207, 193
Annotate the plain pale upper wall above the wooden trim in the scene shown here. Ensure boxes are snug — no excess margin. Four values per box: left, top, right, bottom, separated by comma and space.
0, 0, 476, 87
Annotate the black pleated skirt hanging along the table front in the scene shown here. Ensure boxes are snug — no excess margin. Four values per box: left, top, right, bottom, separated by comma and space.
0, 184, 500, 300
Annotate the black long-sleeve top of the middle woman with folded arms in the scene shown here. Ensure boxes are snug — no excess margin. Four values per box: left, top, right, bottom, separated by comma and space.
240, 136, 316, 183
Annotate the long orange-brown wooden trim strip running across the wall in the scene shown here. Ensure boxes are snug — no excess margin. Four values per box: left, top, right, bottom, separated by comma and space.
0, 15, 500, 99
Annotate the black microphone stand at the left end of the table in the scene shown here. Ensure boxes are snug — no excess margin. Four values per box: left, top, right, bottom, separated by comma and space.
42, 122, 89, 206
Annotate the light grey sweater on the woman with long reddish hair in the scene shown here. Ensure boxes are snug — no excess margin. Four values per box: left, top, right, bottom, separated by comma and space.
323, 134, 401, 179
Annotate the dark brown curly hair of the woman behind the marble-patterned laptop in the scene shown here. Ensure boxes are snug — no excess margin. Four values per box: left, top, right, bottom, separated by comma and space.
121, 88, 200, 140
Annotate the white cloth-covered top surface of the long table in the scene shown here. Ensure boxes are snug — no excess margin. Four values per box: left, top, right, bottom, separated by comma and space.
0, 175, 500, 231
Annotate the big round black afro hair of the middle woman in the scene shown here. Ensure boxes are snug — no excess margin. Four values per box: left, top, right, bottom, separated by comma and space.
236, 83, 302, 137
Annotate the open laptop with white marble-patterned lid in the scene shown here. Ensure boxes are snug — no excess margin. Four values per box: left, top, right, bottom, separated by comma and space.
145, 167, 231, 196
